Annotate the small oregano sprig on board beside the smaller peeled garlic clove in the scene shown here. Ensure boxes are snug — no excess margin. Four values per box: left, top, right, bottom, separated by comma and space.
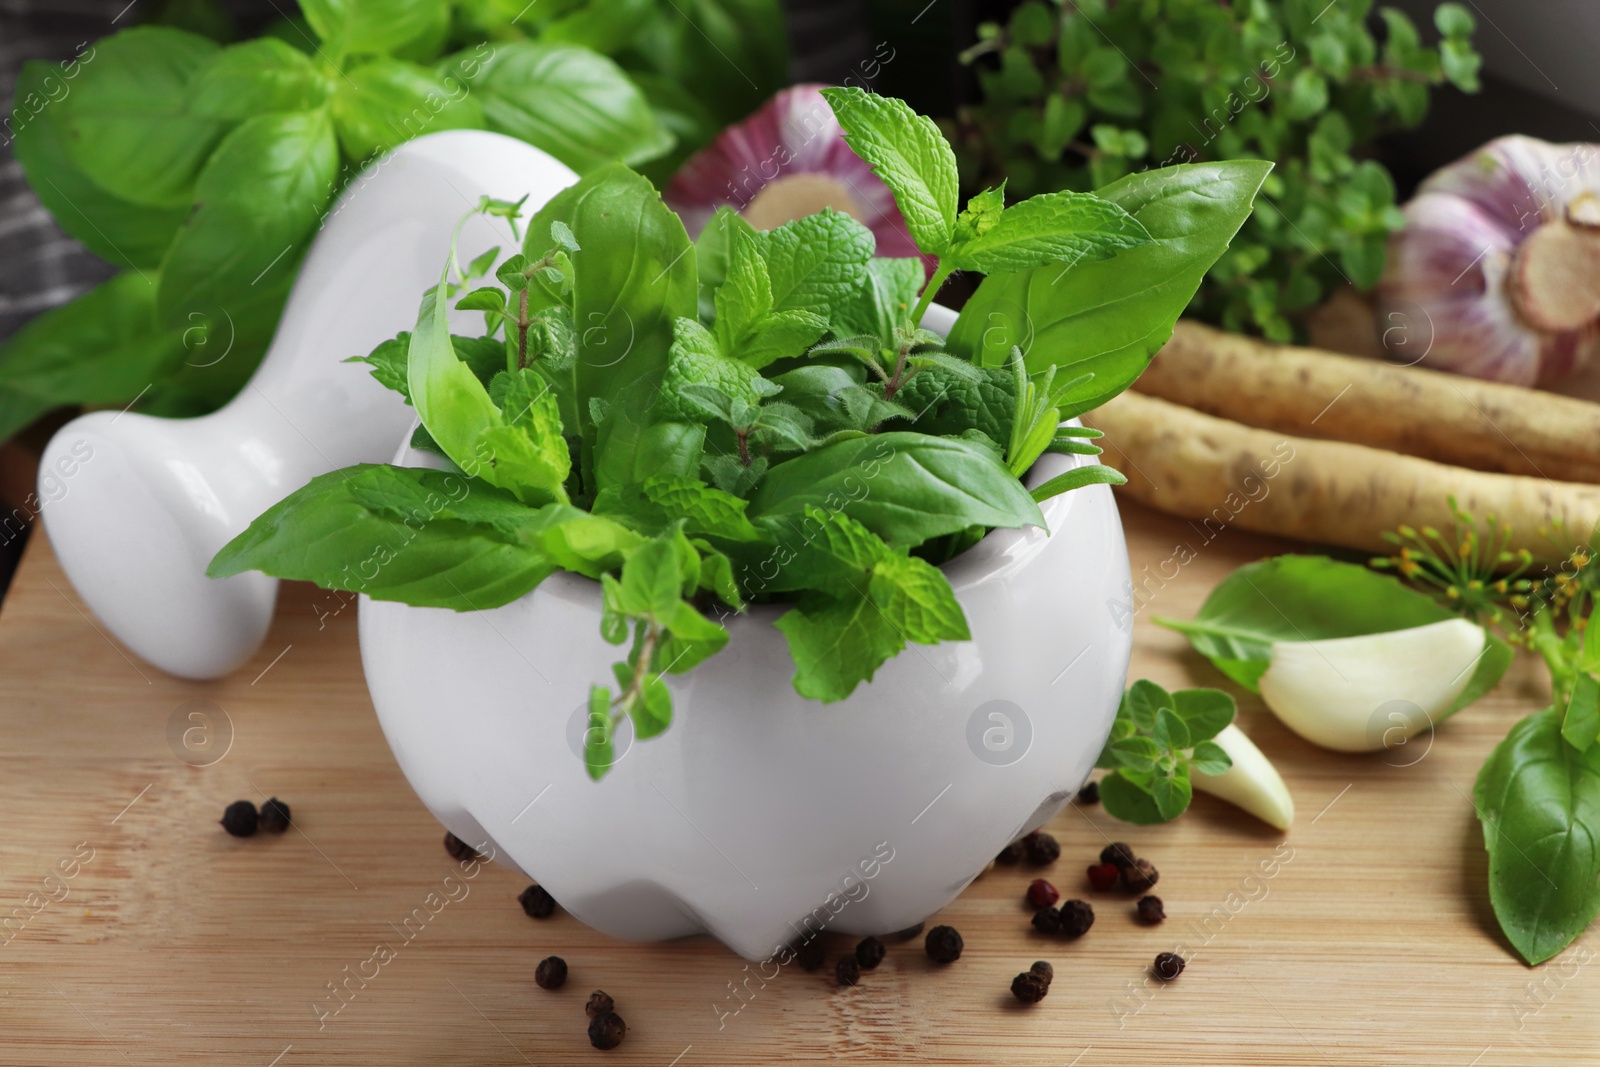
1094, 680, 1235, 825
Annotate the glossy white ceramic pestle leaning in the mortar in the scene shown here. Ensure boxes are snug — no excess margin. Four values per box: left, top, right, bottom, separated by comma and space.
38, 130, 576, 678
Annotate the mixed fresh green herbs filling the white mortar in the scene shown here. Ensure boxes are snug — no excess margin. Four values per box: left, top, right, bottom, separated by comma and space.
210, 90, 1267, 777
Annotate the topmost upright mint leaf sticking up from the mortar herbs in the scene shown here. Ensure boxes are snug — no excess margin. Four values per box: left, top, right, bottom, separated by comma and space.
822, 88, 960, 256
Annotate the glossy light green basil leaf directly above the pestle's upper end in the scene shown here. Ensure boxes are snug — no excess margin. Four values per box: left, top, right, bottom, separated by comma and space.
443, 42, 672, 173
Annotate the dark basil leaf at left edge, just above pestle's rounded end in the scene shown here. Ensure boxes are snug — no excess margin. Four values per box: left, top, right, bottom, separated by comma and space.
0, 270, 186, 409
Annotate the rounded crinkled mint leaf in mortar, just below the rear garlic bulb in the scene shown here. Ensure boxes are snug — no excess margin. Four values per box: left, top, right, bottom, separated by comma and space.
761, 208, 875, 322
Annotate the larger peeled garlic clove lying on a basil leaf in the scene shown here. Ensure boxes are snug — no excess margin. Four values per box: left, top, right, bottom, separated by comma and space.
1259, 619, 1488, 752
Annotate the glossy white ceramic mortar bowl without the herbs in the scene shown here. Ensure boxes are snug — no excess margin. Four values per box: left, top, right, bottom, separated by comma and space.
360, 303, 1131, 960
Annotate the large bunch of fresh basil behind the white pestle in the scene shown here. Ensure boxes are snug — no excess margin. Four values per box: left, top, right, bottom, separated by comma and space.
0, 0, 784, 440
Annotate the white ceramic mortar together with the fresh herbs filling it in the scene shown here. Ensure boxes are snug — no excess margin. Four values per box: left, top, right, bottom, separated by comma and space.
210, 90, 1269, 958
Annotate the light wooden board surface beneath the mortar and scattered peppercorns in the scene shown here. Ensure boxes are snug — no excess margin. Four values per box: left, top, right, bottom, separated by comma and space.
0, 502, 1600, 1067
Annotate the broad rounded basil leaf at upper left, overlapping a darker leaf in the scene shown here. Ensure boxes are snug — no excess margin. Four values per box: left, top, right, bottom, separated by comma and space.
59, 26, 227, 208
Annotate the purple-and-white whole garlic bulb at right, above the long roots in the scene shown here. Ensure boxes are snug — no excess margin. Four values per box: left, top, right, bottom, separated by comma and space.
1378, 136, 1600, 386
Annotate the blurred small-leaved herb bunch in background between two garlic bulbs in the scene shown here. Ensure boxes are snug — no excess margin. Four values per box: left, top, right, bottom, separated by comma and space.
949, 0, 1480, 341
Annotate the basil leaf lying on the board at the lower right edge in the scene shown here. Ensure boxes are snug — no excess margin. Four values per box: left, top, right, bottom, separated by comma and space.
1474, 707, 1600, 963
